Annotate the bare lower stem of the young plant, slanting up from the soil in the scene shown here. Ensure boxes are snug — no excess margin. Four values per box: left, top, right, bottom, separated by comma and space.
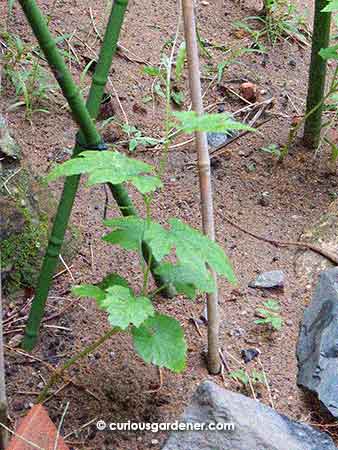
36, 328, 120, 403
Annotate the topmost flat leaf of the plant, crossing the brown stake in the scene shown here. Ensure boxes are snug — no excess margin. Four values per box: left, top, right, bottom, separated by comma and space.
173, 111, 255, 133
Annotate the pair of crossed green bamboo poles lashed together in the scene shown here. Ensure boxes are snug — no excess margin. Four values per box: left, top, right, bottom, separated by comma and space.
19, 0, 172, 351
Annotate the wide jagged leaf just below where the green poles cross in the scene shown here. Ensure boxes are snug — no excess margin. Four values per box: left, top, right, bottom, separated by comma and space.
47, 150, 161, 194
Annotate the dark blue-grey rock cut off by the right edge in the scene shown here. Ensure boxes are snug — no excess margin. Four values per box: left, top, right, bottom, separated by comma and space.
297, 268, 338, 418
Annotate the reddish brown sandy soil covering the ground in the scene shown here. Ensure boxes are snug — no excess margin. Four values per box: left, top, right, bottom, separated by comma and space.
1, 0, 338, 450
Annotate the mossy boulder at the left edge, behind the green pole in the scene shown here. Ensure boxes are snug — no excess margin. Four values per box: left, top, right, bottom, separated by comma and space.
0, 114, 78, 292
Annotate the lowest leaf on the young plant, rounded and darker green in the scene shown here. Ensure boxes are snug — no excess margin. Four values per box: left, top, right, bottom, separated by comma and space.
132, 314, 187, 372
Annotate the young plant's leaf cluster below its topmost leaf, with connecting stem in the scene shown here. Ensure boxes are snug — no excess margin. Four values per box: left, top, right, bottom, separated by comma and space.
48, 151, 235, 372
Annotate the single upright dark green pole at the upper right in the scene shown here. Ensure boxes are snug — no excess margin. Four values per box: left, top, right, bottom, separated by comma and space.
303, 0, 331, 149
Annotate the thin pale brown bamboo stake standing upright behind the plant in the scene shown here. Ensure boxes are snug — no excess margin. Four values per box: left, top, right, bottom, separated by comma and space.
182, 0, 221, 374
